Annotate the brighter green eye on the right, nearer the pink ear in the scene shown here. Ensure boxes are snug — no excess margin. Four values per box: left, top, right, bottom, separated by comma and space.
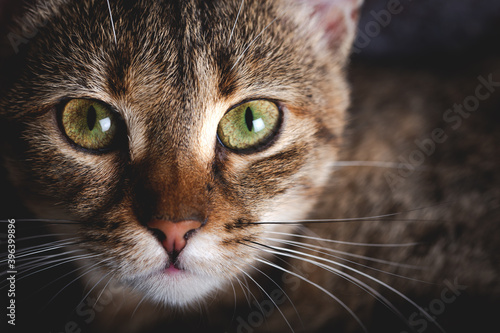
217, 99, 280, 150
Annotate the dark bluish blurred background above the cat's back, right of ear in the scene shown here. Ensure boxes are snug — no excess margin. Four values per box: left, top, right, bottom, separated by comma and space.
353, 0, 500, 63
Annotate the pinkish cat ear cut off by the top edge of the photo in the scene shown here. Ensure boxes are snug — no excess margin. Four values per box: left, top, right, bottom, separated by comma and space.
296, 0, 363, 59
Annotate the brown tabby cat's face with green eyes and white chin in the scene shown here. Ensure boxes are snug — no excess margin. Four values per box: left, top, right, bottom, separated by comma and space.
0, 1, 356, 306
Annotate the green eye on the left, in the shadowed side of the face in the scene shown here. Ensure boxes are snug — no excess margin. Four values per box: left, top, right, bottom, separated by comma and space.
61, 99, 118, 150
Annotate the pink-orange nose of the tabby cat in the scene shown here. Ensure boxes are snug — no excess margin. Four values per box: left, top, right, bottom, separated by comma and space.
148, 220, 201, 253
